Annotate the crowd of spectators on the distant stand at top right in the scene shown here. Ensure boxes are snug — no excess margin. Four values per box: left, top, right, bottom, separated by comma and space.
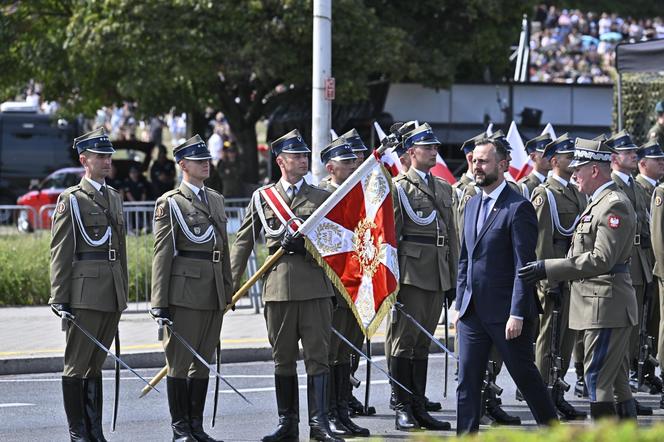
529, 4, 664, 83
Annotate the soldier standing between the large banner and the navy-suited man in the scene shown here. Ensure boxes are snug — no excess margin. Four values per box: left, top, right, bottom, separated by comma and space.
390, 123, 458, 430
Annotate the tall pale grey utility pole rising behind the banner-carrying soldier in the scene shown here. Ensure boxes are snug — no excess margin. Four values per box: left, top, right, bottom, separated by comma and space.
311, 0, 335, 183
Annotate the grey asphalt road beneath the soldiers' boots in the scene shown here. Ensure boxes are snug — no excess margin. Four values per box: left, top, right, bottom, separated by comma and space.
0, 355, 664, 442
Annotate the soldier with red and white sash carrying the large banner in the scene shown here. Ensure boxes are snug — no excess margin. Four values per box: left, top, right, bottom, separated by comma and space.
231, 130, 341, 442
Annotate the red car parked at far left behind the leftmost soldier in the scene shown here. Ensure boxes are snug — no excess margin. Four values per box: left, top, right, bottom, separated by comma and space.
17, 167, 85, 232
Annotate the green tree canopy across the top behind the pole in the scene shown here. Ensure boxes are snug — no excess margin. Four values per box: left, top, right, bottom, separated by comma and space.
0, 0, 532, 181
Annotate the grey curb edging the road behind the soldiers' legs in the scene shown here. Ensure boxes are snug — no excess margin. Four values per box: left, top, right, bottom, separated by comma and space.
0, 336, 454, 376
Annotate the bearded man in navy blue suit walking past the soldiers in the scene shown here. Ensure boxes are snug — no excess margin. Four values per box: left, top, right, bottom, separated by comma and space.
456, 139, 557, 434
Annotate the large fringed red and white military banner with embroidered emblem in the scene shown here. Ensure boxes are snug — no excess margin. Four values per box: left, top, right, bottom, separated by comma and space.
298, 152, 399, 338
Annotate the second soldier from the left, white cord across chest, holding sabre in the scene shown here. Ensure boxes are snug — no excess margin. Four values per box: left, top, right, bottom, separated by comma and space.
151, 135, 233, 441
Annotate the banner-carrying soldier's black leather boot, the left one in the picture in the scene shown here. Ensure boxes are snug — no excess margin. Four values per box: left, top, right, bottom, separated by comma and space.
262, 374, 300, 442
